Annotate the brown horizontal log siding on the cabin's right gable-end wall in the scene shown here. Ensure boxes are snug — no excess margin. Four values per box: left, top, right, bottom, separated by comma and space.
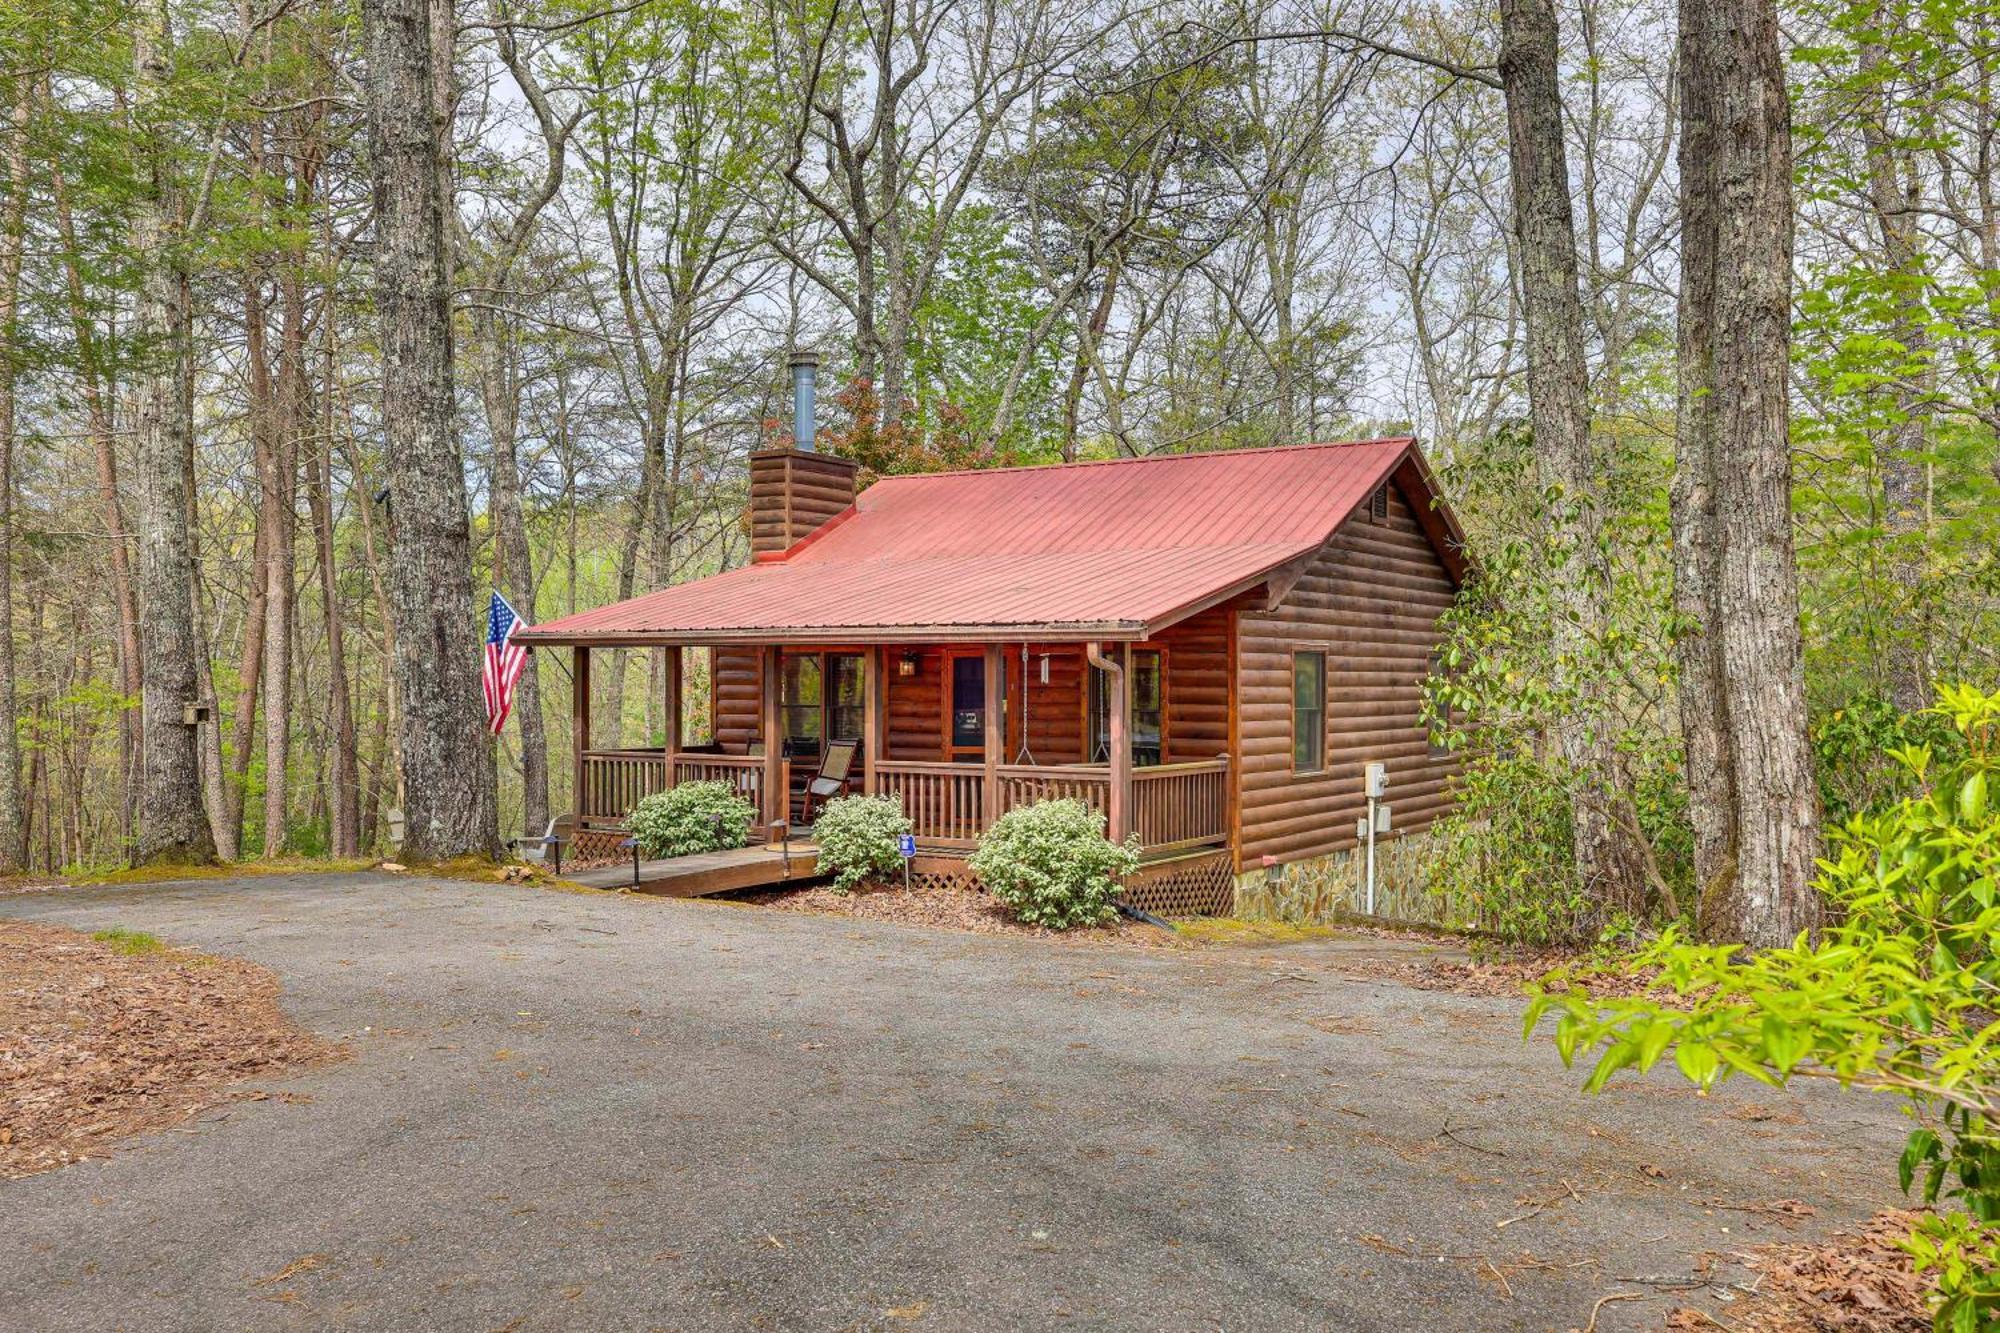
1236, 486, 1458, 867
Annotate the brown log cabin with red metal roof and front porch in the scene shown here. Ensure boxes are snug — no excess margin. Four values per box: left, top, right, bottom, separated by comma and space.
520, 368, 1466, 915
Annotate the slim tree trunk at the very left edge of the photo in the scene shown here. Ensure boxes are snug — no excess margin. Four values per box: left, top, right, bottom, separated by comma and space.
0, 94, 28, 860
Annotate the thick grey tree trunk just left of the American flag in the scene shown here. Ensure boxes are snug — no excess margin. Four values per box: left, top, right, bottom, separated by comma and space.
362, 0, 498, 861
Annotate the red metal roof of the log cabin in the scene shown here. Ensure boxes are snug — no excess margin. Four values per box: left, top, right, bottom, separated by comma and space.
522, 438, 1448, 642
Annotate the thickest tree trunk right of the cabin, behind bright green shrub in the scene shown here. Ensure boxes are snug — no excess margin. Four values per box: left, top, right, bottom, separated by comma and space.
1678, 0, 1820, 947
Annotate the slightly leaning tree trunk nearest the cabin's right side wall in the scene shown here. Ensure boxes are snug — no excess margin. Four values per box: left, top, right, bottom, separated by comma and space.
1500, 0, 1644, 915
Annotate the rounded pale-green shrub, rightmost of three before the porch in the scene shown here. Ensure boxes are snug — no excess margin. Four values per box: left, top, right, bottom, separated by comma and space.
970, 801, 1138, 931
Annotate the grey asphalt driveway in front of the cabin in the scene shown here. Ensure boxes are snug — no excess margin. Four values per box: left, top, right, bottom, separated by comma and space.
0, 875, 1904, 1329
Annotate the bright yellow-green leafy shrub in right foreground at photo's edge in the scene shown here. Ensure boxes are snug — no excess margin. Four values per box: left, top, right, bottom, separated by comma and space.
1526, 687, 2000, 1331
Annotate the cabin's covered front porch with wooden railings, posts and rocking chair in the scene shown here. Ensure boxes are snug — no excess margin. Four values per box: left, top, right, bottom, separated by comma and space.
572, 616, 1234, 861
